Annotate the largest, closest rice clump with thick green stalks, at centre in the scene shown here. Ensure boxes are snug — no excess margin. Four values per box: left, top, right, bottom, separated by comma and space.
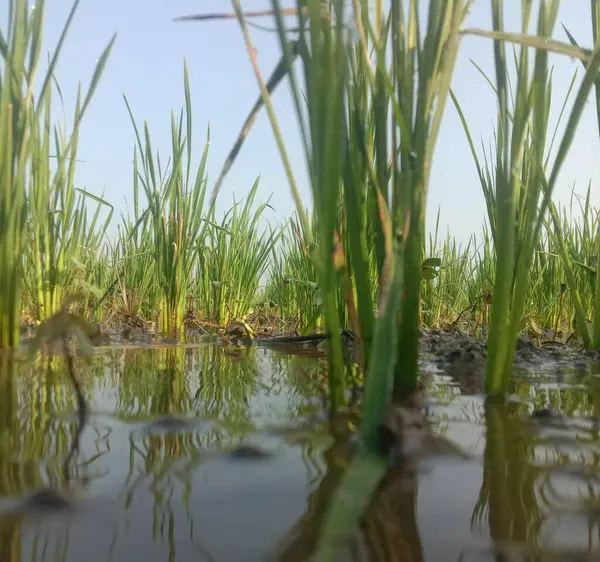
218, 0, 470, 420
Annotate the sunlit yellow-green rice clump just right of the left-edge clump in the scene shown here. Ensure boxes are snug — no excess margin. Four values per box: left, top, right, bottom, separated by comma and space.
29, 80, 113, 321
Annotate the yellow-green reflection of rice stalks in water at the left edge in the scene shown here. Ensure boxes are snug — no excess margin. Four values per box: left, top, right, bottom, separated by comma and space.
0, 353, 91, 561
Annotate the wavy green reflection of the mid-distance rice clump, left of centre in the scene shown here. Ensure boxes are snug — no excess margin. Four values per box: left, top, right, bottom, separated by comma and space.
116, 347, 257, 552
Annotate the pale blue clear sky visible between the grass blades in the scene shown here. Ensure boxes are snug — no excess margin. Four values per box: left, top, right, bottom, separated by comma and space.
30, 0, 600, 240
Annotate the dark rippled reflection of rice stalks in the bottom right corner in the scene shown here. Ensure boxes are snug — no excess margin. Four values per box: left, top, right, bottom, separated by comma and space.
458, 390, 600, 560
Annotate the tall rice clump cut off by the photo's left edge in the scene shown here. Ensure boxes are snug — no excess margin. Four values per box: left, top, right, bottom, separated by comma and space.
0, 0, 115, 347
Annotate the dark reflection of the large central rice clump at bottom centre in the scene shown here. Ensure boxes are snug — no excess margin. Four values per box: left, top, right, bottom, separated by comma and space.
276, 406, 423, 562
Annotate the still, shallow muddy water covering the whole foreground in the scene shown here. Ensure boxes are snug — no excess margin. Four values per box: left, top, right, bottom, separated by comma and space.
0, 346, 600, 562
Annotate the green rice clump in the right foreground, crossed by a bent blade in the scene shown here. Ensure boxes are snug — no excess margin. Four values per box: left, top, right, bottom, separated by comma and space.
453, 0, 600, 394
